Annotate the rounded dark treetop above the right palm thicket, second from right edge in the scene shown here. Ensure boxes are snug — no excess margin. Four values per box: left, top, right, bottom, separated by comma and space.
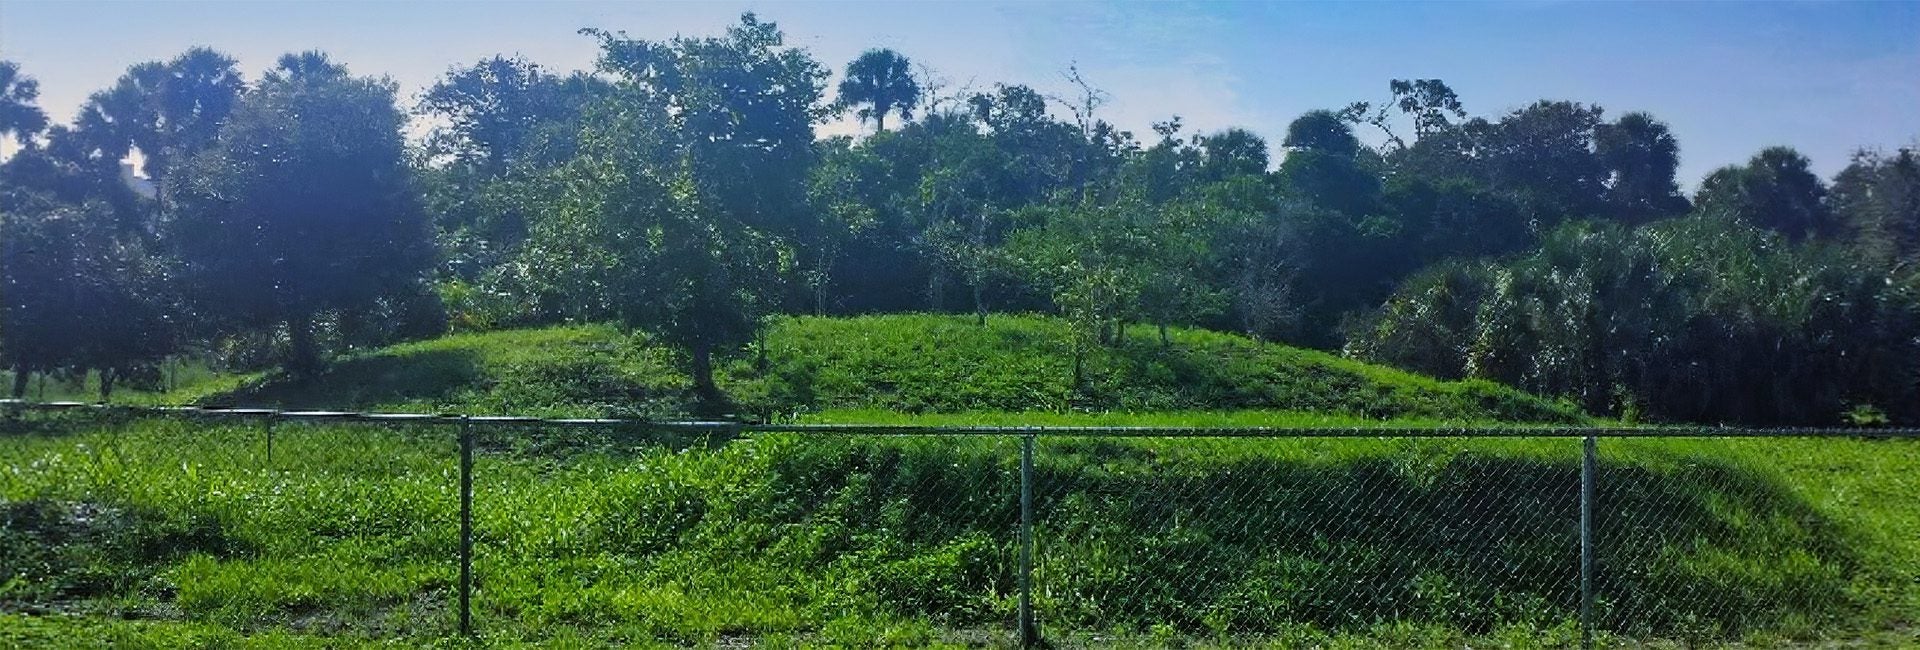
1693, 146, 1836, 240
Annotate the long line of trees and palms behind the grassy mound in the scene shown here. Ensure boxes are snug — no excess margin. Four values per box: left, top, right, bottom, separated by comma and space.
0, 13, 1920, 424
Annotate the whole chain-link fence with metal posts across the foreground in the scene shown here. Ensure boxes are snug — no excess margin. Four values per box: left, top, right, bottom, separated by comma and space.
0, 403, 1920, 646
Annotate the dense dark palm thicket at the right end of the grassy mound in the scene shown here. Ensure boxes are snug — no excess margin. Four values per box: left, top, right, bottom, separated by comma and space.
1350, 217, 1920, 426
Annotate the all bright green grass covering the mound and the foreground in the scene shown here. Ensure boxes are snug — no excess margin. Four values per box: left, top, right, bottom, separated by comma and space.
0, 316, 1920, 648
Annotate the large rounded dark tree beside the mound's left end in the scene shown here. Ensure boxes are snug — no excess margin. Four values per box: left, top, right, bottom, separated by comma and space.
167, 52, 432, 374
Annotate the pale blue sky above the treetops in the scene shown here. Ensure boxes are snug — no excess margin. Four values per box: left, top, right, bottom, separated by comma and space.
0, 0, 1920, 186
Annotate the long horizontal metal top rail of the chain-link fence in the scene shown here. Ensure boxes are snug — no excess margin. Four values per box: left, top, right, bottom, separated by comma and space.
0, 399, 1920, 439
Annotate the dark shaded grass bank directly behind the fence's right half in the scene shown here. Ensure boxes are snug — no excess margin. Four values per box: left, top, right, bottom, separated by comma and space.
772, 439, 1859, 638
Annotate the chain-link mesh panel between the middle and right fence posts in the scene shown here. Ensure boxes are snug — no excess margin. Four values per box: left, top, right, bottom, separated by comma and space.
1035, 437, 1580, 642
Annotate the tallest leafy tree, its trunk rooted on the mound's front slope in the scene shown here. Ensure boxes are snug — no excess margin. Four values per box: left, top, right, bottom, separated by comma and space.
528, 13, 826, 405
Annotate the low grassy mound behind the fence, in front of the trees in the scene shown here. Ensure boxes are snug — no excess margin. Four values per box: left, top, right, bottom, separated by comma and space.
183, 314, 1580, 424
